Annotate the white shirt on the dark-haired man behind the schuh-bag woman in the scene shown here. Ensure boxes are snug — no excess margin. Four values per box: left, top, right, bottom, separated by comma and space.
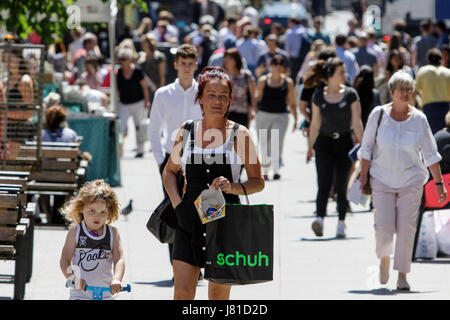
148, 79, 203, 165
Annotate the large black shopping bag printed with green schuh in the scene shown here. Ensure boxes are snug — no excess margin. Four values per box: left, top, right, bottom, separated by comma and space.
205, 184, 273, 285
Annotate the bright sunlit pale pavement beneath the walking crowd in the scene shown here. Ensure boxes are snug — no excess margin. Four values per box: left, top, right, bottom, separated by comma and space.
0, 117, 450, 300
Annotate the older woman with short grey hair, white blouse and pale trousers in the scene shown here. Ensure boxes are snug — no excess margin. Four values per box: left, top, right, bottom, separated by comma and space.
358, 71, 447, 290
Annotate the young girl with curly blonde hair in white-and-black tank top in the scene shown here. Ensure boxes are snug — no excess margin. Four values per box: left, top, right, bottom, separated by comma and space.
60, 180, 125, 300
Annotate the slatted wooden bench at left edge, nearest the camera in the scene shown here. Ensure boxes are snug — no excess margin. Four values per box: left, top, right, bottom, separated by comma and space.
0, 184, 34, 300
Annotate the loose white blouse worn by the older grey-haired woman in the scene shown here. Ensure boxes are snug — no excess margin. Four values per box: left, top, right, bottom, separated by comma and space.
358, 106, 442, 188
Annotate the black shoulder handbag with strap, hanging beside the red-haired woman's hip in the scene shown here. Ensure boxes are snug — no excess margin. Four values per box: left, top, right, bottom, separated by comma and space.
147, 121, 193, 243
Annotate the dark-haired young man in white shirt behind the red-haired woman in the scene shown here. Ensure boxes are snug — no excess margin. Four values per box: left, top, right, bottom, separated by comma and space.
148, 44, 203, 278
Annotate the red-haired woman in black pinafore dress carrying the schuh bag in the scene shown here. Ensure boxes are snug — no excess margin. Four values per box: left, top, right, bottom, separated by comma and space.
163, 67, 264, 300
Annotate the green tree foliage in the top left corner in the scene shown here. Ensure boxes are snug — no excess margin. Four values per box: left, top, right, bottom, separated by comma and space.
0, 0, 148, 44
